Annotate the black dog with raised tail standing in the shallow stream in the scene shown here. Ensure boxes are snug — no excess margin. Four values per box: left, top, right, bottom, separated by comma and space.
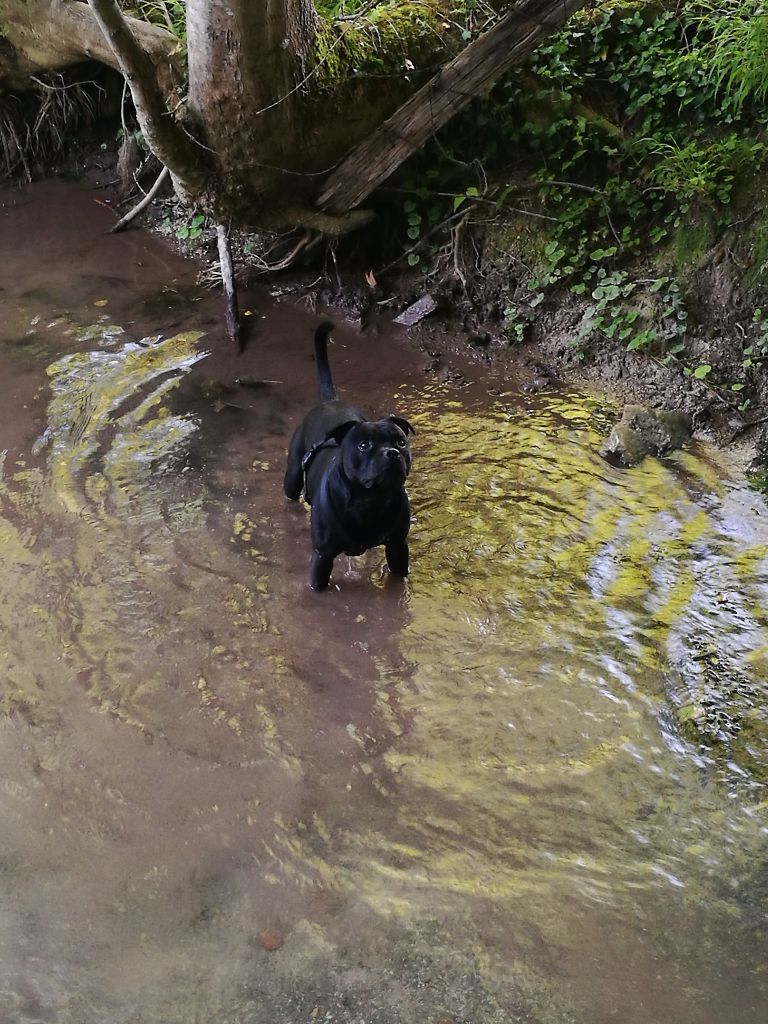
283, 323, 414, 590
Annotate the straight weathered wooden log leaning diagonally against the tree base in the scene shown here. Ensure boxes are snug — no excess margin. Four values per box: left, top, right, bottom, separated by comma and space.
316, 0, 585, 214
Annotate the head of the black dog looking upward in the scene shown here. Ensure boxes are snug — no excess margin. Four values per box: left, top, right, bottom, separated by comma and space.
329, 416, 416, 489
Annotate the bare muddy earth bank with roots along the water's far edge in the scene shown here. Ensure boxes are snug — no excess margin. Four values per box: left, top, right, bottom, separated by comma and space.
58, 143, 768, 465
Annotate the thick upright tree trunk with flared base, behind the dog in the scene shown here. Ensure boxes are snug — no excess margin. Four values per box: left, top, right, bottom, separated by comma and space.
186, 0, 423, 228
